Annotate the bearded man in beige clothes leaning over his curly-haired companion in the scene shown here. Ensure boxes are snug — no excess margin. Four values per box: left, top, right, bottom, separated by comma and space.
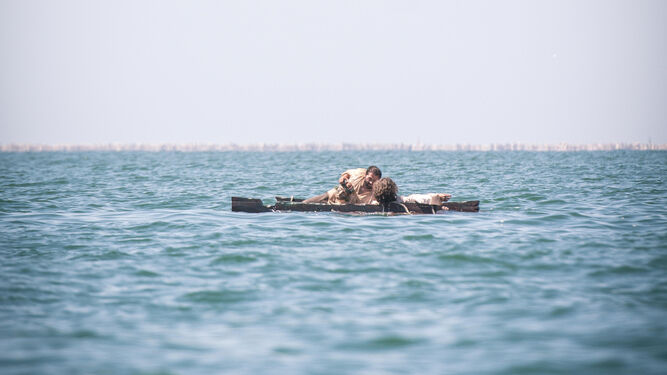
303, 165, 382, 204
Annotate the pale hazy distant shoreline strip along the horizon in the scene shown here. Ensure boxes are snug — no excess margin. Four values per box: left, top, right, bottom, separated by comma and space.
0, 143, 667, 152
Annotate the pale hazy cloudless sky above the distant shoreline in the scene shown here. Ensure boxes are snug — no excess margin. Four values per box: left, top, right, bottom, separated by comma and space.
0, 0, 667, 144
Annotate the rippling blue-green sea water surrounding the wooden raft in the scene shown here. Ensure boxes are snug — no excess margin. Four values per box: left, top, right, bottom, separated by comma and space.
0, 151, 667, 374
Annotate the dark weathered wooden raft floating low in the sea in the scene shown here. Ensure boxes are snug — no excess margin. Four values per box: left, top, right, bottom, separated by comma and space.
232, 197, 479, 214
